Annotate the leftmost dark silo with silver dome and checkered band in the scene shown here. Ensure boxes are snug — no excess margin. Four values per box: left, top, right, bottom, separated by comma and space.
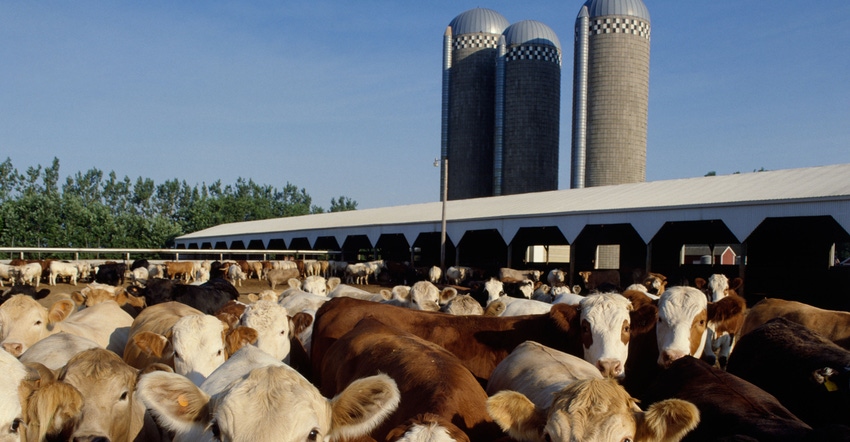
440, 8, 509, 200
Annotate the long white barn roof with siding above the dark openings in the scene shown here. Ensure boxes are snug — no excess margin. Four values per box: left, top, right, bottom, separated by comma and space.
176, 164, 850, 249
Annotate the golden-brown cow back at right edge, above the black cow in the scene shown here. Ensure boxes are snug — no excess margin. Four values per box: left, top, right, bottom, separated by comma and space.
741, 298, 850, 350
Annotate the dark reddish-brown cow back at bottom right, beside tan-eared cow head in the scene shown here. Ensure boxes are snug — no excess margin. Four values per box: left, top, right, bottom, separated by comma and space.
640, 353, 848, 442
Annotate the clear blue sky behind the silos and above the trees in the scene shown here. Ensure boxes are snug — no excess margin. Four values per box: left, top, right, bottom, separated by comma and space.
0, 0, 850, 209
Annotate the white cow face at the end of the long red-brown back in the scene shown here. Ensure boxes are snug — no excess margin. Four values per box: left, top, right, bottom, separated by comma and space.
579, 293, 632, 378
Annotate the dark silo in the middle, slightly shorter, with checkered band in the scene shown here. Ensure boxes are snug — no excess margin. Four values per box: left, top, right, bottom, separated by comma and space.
493, 20, 561, 195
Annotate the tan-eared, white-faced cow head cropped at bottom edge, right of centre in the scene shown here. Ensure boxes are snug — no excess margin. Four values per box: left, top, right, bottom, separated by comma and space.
487, 379, 699, 442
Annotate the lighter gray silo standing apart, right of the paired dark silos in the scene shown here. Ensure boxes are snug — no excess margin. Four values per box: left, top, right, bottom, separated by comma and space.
570, 0, 650, 188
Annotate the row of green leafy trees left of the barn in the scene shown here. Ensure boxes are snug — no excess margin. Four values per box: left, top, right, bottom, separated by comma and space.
0, 158, 357, 248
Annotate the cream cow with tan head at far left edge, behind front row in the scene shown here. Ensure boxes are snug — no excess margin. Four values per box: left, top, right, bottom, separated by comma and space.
0, 295, 133, 356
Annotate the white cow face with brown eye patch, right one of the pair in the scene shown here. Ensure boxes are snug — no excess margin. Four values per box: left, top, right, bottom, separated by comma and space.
655, 286, 709, 367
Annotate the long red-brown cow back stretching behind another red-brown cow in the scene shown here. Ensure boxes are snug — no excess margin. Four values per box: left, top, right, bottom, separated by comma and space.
311, 297, 582, 381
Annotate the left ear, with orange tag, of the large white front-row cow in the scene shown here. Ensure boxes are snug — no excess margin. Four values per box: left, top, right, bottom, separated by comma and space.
136, 371, 211, 434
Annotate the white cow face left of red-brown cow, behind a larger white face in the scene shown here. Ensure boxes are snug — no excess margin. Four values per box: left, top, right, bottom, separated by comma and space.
240, 301, 292, 363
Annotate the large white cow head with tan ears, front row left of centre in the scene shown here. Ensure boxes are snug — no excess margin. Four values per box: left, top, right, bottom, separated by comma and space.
137, 346, 401, 442
